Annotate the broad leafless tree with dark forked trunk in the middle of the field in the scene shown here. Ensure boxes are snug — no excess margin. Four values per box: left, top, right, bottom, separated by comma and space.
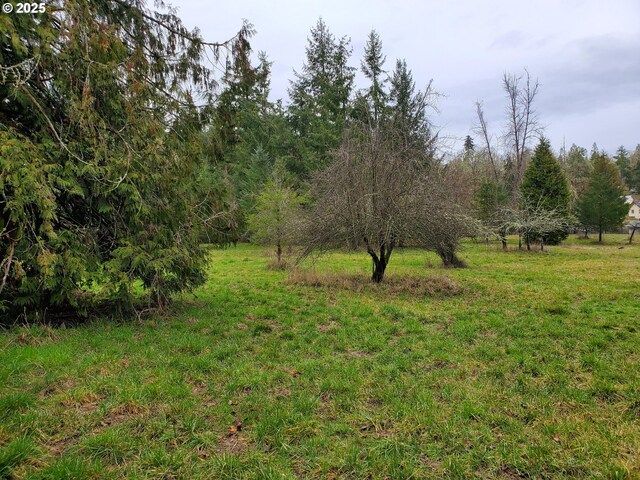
301, 124, 476, 283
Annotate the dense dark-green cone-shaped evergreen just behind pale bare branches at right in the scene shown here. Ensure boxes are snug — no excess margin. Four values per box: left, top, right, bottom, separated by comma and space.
520, 138, 570, 244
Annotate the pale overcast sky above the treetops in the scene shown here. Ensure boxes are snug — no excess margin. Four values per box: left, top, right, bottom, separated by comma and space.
170, 0, 640, 153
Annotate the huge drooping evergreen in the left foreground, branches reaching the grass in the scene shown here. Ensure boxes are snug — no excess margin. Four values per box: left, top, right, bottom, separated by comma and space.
0, 0, 252, 319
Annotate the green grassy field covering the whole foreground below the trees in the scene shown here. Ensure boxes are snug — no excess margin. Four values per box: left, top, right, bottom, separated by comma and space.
0, 235, 640, 479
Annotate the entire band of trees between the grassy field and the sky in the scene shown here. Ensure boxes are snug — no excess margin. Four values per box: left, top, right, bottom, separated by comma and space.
0, 4, 640, 321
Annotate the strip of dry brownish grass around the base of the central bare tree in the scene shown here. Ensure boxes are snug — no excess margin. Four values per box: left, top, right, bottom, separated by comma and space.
288, 271, 461, 297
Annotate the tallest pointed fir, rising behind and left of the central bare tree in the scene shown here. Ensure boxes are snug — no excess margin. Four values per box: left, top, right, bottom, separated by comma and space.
288, 18, 355, 177
